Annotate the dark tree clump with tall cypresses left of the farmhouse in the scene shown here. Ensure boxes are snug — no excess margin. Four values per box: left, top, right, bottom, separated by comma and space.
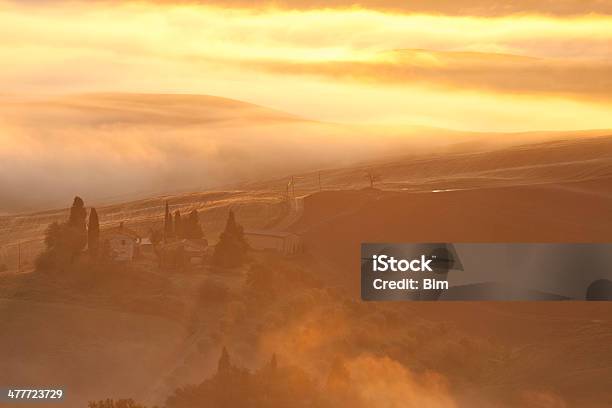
36, 197, 100, 270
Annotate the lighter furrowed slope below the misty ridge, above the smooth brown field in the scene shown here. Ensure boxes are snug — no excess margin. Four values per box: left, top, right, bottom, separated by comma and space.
244, 131, 612, 193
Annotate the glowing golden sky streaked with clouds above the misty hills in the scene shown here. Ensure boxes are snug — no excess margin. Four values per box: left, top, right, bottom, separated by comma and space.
0, 0, 612, 131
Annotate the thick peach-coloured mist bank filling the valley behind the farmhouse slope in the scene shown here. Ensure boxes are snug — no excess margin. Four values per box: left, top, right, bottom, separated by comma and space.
0, 94, 436, 212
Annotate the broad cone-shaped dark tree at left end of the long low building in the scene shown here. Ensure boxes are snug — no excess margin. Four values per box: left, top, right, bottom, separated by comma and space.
213, 210, 248, 268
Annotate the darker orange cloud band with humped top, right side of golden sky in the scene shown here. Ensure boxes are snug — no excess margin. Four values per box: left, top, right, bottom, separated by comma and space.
240, 50, 612, 99
